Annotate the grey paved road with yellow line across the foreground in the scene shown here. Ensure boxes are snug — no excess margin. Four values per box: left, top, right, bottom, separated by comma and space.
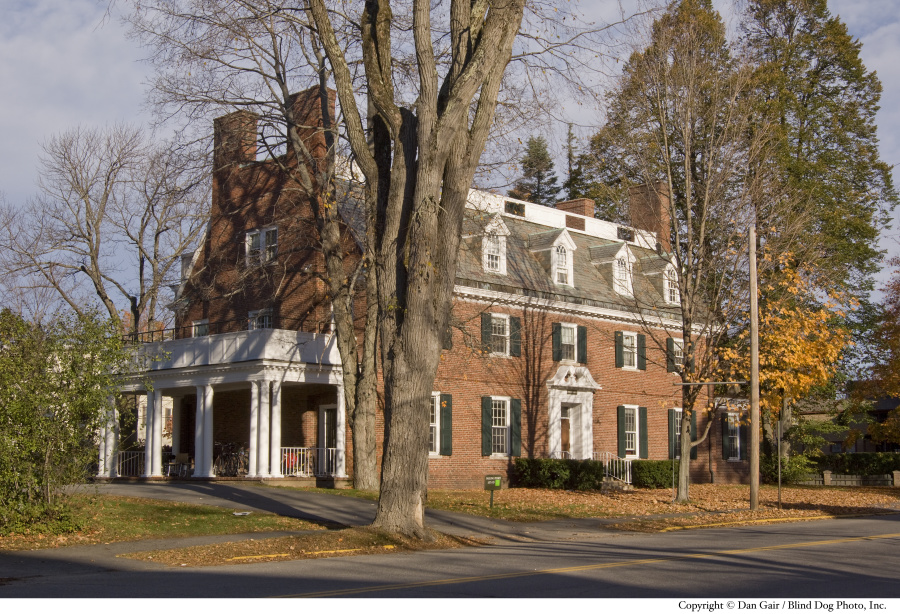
0, 485, 900, 609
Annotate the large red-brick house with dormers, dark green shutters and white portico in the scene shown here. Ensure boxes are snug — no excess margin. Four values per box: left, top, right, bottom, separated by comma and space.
103, 88, 747, 488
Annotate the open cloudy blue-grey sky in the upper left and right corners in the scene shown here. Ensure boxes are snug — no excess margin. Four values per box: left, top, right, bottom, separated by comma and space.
0, 0, 900, 280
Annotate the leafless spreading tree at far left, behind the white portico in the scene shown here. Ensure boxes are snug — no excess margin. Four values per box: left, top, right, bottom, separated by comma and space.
0, 125, 206, 333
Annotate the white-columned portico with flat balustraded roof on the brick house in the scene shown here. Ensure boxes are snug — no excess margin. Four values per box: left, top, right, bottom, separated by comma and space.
99, 329, 347, 479
